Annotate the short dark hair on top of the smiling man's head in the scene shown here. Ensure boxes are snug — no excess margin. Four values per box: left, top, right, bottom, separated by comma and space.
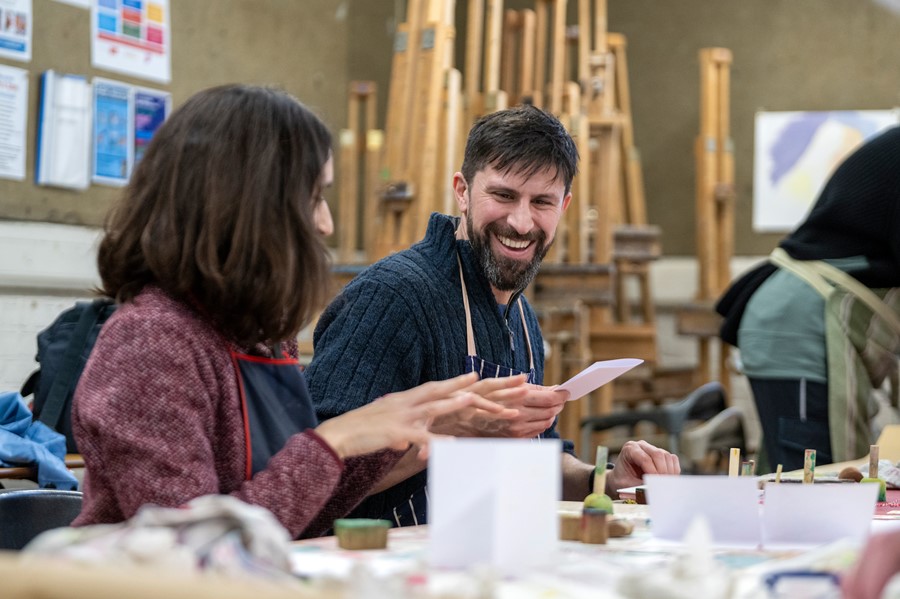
461, 104, 578, 193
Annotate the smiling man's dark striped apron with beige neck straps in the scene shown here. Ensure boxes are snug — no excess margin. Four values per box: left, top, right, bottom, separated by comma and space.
386, 256, 536, 526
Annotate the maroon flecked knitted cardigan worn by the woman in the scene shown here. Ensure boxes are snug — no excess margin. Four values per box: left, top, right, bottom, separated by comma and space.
73, 302, 395, 537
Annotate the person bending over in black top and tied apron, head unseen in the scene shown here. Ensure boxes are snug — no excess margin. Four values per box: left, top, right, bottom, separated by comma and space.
716, 127, 900, 470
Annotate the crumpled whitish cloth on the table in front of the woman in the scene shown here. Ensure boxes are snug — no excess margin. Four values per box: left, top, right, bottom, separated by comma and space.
23, 495, 291, 579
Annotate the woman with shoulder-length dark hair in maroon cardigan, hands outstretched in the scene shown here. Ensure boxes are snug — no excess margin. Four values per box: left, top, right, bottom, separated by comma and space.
72, 85, 525, 537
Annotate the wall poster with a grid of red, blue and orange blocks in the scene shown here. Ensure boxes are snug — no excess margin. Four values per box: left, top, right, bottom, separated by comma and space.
93, 0, 172, 83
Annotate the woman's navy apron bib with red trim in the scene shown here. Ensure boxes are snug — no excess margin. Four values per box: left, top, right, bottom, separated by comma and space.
231, 344, 318, 480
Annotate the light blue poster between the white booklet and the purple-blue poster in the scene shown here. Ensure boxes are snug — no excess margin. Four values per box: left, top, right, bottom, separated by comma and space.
91, 79, 134, 186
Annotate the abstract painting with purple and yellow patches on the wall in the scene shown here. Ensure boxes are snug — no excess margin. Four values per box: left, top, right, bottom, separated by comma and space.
753, 110, 898, 233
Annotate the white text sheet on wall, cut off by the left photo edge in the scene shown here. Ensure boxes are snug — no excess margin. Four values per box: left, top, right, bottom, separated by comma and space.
0, 65, 28, 181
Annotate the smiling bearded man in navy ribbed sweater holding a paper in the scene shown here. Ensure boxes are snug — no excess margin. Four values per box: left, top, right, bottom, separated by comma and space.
307, 106, 679, 526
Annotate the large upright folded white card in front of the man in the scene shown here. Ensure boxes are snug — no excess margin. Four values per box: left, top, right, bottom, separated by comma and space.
428, 439, 562, 574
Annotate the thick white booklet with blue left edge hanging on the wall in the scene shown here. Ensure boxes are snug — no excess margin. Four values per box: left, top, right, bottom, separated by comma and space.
35, 70, 91, 189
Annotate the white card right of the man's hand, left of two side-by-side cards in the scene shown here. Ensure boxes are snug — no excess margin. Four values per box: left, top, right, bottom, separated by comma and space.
644, 474, 761, 547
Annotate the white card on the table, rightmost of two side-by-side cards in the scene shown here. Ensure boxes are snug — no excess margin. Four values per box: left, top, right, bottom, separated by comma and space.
762, 484, 878, 547
